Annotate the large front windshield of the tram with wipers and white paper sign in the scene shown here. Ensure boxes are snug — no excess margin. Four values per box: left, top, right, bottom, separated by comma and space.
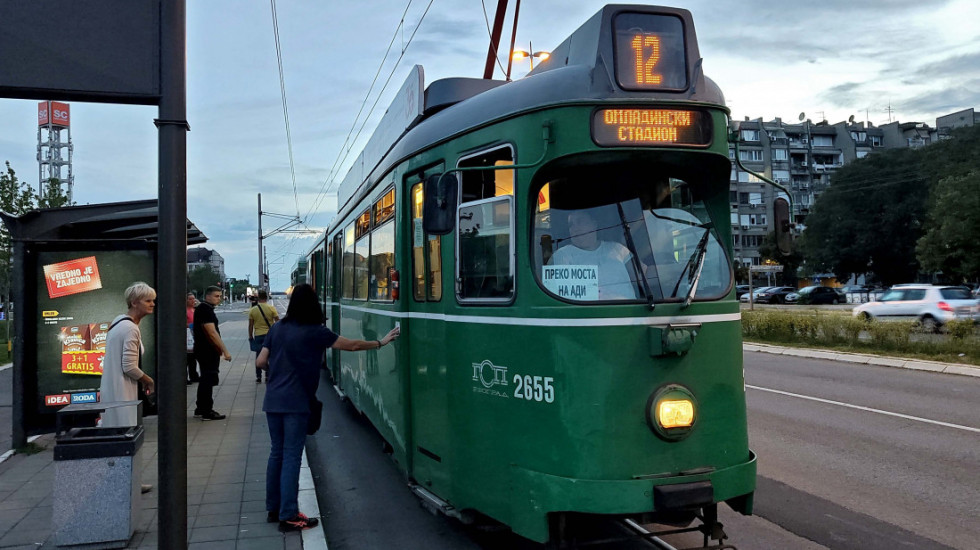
531, 170, 732, 304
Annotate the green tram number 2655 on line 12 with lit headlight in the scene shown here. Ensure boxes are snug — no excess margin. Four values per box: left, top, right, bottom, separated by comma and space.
307, 5, 756, 544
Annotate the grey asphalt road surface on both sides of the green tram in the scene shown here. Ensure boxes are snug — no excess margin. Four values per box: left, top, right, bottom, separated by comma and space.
302, 352, 980, 550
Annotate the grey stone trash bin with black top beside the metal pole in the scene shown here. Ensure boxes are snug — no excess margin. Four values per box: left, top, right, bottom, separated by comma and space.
53, 401, 143, 548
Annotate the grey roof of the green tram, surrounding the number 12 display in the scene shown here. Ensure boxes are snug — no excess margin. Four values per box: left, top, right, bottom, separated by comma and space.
331, 4, 725, 225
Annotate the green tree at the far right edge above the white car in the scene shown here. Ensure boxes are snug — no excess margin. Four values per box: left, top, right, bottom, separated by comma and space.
915, 170, 980, 282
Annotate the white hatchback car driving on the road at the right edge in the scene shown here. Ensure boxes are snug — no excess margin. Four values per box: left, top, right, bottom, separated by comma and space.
853, 284, 980, 331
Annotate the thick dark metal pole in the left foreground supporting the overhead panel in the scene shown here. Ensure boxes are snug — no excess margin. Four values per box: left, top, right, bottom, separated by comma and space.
155, 0, 189, 550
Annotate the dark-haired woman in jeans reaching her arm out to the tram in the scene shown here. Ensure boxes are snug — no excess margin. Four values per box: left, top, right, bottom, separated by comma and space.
255, 284, 400, 531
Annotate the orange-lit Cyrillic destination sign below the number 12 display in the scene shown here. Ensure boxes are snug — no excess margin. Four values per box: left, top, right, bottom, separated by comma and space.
592, 109, 712, 147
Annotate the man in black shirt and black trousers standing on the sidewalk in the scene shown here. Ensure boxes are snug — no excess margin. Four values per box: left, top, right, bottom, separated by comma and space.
194, 286, 231, 420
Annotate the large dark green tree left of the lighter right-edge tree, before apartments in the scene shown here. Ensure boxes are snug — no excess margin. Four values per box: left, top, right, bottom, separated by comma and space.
800, 149, 930, 284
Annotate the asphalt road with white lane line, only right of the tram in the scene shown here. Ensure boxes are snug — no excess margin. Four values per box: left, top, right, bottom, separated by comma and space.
740, 353, 980, 549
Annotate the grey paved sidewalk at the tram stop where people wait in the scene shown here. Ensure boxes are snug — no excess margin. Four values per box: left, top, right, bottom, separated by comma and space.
0, 316, 326, 550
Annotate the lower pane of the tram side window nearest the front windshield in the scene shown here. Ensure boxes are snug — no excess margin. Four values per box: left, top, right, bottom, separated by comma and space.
456, 196, 514, 301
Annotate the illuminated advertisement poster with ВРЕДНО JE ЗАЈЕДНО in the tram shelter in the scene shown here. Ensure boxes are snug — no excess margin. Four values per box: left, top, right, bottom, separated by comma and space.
37, 250, 156, 414
